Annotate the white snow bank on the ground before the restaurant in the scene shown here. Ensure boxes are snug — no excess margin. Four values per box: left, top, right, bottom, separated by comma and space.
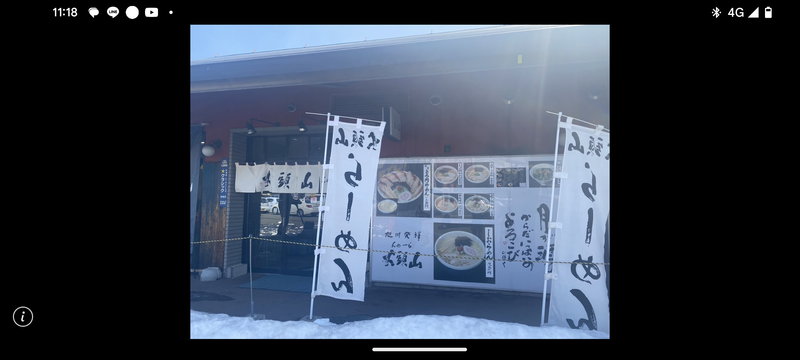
190, 310, 609, 339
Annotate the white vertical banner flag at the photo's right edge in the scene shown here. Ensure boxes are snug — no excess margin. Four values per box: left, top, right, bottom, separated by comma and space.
548, 121, 610, 333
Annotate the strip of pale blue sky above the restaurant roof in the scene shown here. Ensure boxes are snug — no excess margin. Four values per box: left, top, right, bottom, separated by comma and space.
190, 25, 498, 61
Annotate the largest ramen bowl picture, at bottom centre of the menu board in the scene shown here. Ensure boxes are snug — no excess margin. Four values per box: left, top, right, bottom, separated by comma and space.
434, 231, 486, 270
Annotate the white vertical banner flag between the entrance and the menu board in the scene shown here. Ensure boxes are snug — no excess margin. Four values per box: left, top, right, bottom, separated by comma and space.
316, 117, 385, 301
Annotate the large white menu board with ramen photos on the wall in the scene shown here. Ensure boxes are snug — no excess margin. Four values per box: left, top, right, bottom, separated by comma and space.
370, 155, 556, 292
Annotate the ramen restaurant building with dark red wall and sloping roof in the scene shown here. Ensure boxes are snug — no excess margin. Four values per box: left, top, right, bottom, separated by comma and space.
190, 25, 610, 293
